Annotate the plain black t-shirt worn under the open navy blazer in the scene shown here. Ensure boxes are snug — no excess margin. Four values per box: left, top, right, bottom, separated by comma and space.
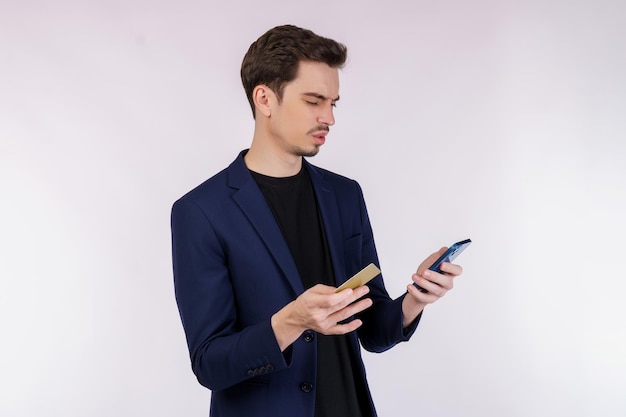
251, 166, 373, 417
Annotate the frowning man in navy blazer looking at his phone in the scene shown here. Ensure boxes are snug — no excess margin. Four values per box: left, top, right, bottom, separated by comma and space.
172, 26, 461, 417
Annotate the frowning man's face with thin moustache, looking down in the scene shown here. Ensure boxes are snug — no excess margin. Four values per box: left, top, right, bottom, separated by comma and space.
269, 61, 339, 156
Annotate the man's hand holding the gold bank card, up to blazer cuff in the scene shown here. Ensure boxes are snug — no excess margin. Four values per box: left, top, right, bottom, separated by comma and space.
272, 284, 372, 351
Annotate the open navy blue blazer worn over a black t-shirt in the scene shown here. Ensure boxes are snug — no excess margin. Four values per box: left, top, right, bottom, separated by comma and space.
171, 151, 419, 417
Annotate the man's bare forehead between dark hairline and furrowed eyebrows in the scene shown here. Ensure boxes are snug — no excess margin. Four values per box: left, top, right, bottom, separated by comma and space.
285, 61, 339, 99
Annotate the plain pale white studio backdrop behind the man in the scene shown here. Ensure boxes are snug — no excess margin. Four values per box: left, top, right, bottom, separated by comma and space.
0, 0, 626, 417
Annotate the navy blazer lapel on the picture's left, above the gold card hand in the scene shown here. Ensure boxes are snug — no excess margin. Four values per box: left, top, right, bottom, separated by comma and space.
227, 151, 304, 296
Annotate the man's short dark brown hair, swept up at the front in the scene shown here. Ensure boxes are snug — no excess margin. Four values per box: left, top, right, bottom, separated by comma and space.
241, 25, 347, 117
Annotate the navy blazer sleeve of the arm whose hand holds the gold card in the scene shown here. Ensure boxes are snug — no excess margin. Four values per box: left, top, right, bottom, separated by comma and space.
171, 197, 289, 390
